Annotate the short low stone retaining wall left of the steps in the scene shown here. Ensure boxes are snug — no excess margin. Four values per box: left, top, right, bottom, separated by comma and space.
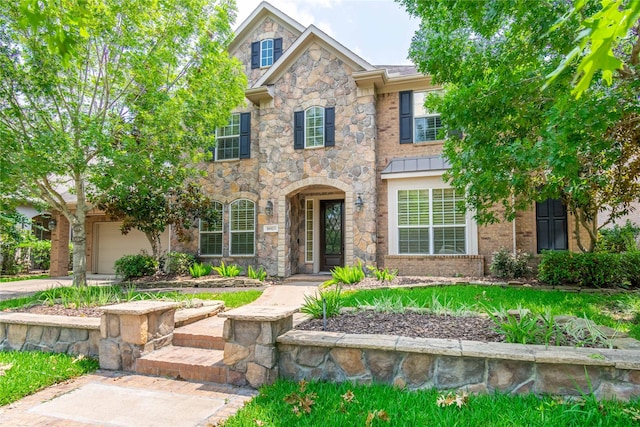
0, 313, 100, 357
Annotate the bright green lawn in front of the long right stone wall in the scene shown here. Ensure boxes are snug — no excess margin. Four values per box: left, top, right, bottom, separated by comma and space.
223, 380, 640, 427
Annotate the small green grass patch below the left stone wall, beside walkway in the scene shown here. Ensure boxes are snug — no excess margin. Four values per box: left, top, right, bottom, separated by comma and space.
0, 351, 99, 406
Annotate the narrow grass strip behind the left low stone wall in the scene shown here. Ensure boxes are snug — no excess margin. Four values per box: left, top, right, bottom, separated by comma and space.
0, 285, 262, 311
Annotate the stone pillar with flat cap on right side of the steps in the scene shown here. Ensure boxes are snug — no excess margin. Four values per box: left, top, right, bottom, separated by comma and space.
218, 305, 297, 388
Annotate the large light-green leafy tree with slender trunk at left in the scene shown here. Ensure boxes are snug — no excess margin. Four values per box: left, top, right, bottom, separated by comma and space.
0, 0, 246, 284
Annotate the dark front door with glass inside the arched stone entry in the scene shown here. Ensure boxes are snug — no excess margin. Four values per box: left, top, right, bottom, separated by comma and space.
320, 200, 344, 271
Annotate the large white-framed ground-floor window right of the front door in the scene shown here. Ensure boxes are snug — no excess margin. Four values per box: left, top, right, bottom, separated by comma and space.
397, 188, 467, 255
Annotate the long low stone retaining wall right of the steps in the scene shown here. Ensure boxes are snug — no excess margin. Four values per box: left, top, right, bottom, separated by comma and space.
277, 330, 640, 400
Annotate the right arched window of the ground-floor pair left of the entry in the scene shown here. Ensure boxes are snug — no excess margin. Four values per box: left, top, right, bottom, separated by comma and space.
229, 199, 256, 255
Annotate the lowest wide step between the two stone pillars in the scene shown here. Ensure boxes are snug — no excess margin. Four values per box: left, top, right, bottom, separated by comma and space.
136, 346, 228, 384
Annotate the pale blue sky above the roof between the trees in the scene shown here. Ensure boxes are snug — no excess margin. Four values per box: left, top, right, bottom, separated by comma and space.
234, 0, 419, 65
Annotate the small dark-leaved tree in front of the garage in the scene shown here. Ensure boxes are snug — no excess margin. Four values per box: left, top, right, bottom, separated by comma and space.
98, 179, 211, 265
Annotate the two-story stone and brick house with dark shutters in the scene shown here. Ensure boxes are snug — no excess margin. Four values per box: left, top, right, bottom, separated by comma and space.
46, 2, 575, 277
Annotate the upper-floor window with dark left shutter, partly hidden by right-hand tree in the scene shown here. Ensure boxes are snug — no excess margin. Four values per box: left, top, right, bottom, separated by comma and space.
400, 91, 442, 144
